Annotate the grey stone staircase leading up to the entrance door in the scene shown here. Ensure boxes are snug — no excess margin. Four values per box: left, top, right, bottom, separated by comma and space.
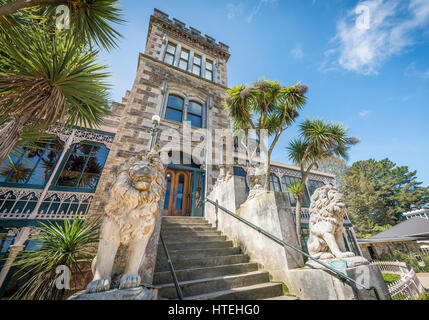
154, 217, 296, 300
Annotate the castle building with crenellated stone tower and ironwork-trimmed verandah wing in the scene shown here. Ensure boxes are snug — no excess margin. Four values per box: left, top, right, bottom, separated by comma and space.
0, 9, 359, 296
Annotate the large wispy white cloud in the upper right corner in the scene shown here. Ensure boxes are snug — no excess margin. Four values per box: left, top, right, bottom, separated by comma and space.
321, 0, 429, 75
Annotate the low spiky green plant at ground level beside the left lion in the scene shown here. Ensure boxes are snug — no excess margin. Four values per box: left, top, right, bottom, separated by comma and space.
12, 219, 98, 300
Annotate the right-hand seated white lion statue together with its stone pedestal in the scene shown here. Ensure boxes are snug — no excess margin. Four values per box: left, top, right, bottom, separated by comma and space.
287, 186, 391, 300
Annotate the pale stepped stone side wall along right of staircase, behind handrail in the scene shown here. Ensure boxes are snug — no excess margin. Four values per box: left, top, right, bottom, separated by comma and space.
205, 177, 304, 290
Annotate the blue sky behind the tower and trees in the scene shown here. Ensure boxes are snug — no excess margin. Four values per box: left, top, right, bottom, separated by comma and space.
98, 0, 429, 186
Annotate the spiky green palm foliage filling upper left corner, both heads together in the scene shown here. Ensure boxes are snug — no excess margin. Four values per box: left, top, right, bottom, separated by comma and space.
0, 0, 124, 163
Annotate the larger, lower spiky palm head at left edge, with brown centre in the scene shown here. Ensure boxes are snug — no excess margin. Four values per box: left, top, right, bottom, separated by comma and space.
0, 26, 110, 163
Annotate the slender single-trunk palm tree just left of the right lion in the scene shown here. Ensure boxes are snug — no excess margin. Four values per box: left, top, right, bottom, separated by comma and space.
287, 119, 359, 246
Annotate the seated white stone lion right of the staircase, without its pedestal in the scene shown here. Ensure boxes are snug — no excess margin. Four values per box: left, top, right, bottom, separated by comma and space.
307, 186, 355, 259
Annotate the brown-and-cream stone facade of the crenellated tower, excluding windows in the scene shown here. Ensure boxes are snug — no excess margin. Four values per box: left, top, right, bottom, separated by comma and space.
89, 9, 229, 221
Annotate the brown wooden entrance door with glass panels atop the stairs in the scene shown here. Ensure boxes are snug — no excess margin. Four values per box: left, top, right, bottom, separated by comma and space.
163, 169, 192, 216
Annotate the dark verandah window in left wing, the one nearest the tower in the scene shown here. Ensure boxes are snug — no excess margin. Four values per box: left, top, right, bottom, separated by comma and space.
54, 142, 109, 192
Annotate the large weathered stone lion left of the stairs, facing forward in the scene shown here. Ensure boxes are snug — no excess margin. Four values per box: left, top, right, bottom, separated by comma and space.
86, 147, 165, 293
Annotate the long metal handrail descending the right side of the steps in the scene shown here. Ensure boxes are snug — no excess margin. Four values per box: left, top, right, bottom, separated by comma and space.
204, 198, 380, 300
